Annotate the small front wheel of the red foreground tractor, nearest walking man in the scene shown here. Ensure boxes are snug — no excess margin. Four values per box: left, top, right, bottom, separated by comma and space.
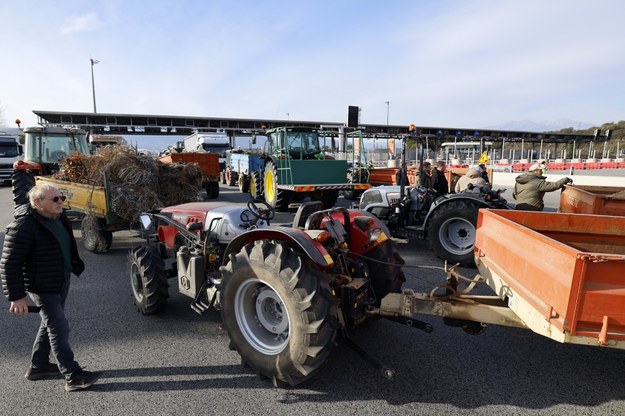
130, 245, 169, 315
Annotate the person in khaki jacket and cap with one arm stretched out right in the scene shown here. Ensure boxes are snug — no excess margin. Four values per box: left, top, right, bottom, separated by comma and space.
512, 163, 573, 211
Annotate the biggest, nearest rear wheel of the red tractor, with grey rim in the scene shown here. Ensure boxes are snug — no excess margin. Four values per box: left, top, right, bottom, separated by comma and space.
221, 240, 338, 386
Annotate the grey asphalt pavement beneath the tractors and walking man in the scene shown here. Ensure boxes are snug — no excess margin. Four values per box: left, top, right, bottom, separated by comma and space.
0, 183, 625, 416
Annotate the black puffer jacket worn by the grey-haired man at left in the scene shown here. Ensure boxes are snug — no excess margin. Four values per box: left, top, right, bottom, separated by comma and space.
0, 205, 85, 301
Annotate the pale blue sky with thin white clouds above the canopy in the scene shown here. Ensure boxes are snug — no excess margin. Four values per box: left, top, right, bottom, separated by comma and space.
0, 0, 625, 134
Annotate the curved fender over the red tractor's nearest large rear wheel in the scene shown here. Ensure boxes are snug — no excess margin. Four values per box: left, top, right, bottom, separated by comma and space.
222, 227, 334, 270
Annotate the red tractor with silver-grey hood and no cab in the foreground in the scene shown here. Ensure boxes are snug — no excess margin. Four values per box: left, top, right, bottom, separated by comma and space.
130, 200, 414, 385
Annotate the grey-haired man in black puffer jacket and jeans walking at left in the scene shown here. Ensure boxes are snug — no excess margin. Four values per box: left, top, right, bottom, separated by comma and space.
0, 184, 102, 391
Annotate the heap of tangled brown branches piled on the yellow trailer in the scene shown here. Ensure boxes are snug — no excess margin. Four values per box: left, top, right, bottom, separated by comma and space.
54, 146, 202, 222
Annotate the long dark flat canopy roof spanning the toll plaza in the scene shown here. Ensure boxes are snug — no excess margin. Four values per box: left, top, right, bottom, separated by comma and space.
33, 110, 602, 143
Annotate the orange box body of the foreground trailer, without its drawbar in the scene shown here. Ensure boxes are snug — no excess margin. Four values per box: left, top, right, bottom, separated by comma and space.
475, 210, 625, 348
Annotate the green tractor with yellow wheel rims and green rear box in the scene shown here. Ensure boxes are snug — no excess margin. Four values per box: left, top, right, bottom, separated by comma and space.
255, 127, 370, 211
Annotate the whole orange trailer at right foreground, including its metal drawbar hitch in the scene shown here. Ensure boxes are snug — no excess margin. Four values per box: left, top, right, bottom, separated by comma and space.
371, 209, 625, 349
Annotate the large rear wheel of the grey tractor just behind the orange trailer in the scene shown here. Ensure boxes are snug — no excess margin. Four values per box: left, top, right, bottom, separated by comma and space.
427, 200, 479, 267
